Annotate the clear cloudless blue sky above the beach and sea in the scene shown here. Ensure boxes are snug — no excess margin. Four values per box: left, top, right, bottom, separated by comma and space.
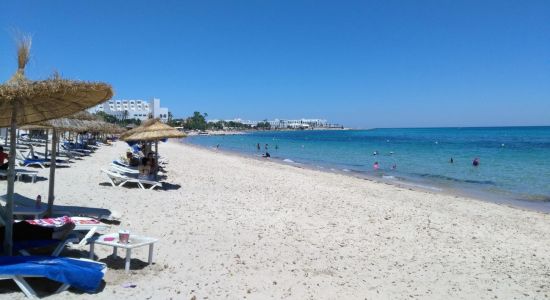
0, 0, 550, 128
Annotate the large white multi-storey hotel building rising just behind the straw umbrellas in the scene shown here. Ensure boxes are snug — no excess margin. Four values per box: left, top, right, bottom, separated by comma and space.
90, 98, 168, 122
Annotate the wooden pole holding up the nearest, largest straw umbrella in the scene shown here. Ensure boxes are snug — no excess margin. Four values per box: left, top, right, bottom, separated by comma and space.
4, 107, 17, 256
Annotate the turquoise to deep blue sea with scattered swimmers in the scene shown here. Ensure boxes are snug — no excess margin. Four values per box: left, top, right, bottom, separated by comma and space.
184, 127, 550, 213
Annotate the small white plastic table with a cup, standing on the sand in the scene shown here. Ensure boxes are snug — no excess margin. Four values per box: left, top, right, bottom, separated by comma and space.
88, 233, 158, 273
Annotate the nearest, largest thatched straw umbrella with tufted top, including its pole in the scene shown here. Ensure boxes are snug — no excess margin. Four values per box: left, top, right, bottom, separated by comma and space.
0, 37, 113, 255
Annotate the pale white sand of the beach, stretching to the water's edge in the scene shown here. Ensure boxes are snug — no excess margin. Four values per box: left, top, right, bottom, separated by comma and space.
0, 143, 550, 299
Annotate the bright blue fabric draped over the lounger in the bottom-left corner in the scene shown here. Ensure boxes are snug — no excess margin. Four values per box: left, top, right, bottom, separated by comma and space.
0, 256, 103, 293
